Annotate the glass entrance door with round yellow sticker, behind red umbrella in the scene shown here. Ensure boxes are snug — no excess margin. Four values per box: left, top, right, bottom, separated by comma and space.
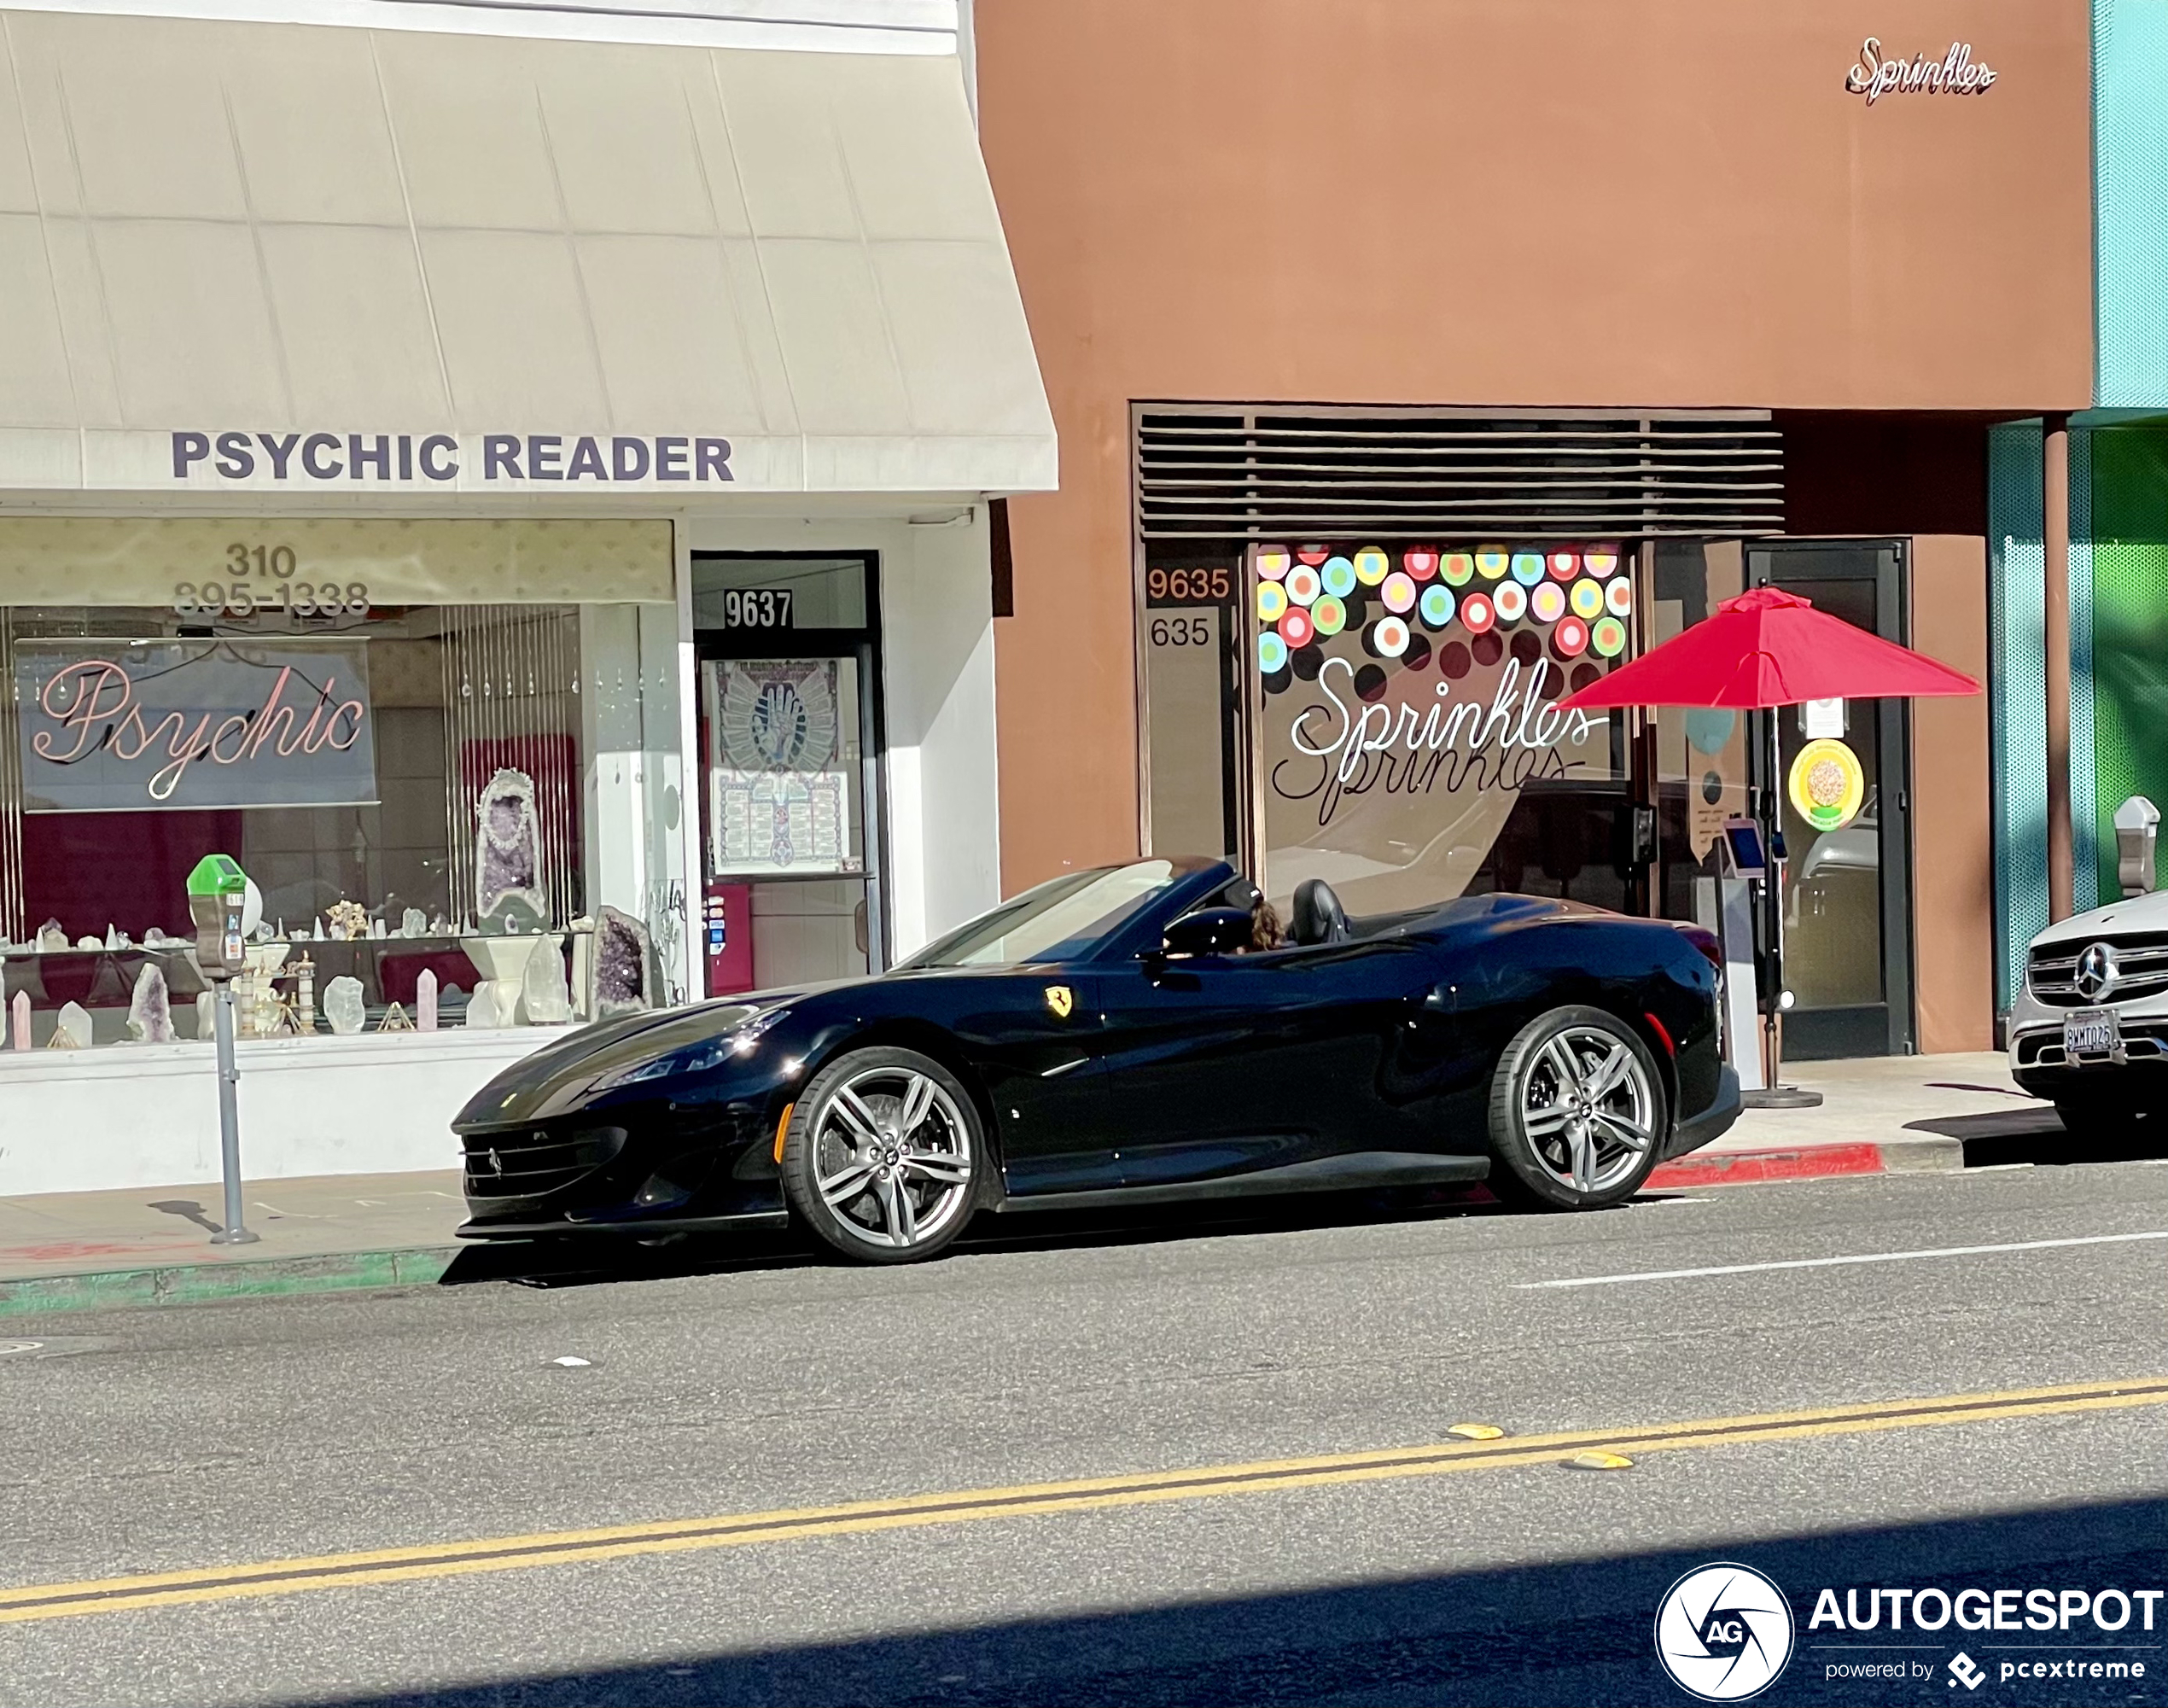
1747, 539, 1912, 1060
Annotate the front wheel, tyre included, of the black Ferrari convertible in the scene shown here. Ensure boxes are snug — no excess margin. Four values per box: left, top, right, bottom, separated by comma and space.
783, 1049, 987, 1263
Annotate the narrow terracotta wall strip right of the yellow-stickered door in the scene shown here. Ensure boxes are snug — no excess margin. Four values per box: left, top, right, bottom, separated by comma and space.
1912, 533, 1995, 1056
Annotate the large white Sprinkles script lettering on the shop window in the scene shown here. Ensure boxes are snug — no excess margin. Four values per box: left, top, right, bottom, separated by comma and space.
1273, 659, 1595, 825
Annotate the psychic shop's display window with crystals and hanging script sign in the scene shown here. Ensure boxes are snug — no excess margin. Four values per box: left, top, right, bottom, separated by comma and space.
0, 520, 683, 1047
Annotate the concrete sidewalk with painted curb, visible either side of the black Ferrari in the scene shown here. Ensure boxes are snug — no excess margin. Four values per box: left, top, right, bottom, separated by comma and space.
0, 1053, 2096, 1315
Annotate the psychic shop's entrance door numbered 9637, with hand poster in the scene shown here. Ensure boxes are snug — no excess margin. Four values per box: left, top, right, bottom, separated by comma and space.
691, 553, 889, 997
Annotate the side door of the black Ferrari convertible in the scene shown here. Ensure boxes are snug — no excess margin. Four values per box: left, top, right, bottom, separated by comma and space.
1099, 939, 1435, 1186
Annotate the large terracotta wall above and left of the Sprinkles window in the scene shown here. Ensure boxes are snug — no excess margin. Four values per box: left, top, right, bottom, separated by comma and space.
976, 0, 2092, 889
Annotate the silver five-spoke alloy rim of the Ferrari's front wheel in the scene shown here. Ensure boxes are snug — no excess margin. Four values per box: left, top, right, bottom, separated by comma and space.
813, 1066, 971, 1249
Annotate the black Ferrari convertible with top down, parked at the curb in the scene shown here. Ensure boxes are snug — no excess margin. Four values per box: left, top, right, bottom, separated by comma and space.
455, 860, 1739, 1263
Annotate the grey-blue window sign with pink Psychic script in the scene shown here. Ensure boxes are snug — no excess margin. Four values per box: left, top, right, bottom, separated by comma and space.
15, 639, 377, 813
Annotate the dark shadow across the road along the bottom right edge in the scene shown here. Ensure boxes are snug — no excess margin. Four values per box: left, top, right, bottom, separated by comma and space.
316, 1472, 2168, 1708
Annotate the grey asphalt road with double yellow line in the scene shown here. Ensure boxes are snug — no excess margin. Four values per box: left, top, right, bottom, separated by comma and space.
0, 1164, 2168, 1708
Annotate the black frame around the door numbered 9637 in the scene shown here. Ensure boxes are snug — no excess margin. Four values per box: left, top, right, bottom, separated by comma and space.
691, 551, 895, 973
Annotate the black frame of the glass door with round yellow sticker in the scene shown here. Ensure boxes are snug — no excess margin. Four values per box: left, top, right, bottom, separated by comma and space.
1745, 538, 1919, 1060
